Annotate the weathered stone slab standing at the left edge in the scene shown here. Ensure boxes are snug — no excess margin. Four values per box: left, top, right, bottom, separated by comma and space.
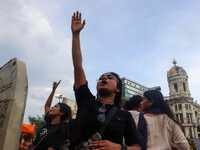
0, 58, 28, 150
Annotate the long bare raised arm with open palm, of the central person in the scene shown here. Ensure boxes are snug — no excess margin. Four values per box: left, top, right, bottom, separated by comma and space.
71, 11, 86, 89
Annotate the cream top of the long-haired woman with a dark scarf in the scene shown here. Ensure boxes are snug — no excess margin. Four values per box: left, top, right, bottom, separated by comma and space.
135, 114, 189, 150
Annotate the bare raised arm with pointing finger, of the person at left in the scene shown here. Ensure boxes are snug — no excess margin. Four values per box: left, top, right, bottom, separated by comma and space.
44, 80, 61, 114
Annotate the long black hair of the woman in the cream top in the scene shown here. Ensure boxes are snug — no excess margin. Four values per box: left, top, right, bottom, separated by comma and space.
144, 90, 179, 125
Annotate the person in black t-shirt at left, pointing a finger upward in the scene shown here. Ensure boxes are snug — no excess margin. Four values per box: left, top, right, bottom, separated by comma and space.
34, 81, 71, 150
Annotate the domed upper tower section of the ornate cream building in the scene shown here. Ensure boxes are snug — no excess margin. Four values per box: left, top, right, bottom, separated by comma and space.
167, 59, 192, 100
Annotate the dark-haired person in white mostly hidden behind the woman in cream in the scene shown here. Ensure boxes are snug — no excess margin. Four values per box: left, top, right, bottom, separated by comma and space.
124, 95, 142, 119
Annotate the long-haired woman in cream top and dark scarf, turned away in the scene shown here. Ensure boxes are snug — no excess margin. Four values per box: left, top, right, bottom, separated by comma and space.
135, 90, 190, 150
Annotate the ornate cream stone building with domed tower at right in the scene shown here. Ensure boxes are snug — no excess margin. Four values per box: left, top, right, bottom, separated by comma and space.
166, 60, 200, 138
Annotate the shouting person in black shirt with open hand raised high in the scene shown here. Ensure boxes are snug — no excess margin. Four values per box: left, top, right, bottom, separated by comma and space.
71, 11, 140, 150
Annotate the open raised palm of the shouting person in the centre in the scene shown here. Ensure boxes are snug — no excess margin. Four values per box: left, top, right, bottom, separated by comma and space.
71, 11, 85, 33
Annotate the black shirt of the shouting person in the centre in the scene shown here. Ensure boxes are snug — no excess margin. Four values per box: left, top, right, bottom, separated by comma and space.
72, 83, 139, 146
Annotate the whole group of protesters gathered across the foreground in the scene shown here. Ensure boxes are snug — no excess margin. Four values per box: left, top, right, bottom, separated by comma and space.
28, 11, 196, 150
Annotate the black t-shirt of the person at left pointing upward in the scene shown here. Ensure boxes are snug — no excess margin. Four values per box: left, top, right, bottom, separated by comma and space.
34, 113, 67, 150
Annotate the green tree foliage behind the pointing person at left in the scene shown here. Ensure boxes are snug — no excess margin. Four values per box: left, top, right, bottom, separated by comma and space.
28, 115, 45, 133
